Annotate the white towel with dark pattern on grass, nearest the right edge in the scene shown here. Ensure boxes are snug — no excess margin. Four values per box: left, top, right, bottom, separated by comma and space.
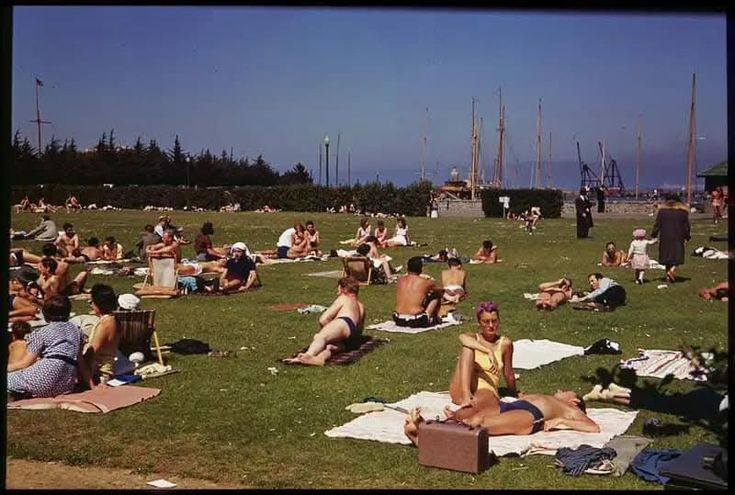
620, 349, 709, 382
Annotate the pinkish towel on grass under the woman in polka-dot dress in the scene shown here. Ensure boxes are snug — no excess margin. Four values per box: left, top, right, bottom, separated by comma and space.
8, 385, 161, 413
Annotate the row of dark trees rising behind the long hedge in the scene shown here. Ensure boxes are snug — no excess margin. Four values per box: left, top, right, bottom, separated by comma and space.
10, 129, 313, 186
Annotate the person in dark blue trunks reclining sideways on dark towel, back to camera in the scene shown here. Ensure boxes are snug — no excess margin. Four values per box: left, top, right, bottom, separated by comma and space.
284, 277, 365, 366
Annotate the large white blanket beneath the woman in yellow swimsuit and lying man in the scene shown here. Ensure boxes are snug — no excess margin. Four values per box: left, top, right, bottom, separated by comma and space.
324, 391, 638, 456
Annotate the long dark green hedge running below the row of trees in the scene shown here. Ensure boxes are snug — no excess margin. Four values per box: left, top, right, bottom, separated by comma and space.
10, 181, 433, 216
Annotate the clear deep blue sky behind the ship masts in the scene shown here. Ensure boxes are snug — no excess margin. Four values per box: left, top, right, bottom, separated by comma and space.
12, 6, 727, 188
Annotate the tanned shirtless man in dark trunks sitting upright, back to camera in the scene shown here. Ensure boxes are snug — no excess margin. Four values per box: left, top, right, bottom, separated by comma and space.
393, 256, 444, 328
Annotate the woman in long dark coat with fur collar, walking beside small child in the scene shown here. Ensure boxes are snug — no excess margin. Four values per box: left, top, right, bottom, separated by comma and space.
651, 194, 691, 283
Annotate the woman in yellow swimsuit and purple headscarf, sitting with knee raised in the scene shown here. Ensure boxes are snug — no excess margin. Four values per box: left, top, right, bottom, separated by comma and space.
449, 301, 516, 407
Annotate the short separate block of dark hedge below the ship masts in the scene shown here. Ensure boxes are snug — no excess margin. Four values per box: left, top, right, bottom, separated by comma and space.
482, 189, 564, 218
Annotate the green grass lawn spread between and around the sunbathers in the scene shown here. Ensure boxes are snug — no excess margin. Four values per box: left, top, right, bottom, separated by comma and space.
7, 211, 727, 489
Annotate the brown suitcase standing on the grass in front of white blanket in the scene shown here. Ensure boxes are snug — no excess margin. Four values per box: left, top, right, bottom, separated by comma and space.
417, 420, 491, 474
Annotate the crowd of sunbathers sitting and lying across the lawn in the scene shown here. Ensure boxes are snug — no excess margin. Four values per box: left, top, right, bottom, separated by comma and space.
8, 207, 728, 444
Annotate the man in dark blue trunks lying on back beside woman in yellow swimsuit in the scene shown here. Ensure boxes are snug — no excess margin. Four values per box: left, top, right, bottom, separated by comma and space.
403, 390, 600, 445
